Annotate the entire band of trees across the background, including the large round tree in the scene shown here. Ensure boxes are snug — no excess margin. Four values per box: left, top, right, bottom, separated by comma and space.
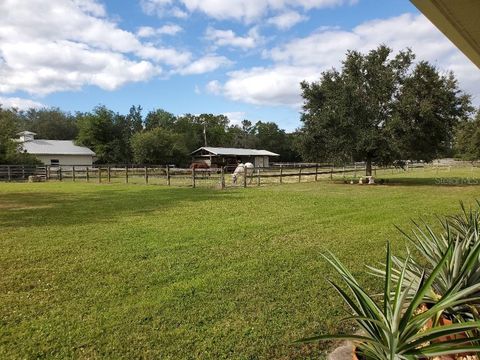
0, 45, 480, 169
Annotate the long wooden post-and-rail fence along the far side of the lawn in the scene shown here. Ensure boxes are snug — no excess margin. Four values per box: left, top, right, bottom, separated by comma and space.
0, 164, 423, 189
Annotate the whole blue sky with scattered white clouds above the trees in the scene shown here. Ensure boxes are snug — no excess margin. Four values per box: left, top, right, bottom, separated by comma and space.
0, 0, 480, 130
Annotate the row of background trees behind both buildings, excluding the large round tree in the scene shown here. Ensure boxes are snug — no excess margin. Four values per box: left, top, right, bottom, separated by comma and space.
0, 105, 301, 166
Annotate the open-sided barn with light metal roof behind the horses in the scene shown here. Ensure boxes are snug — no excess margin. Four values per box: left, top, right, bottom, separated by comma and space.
191, 146, 280, 167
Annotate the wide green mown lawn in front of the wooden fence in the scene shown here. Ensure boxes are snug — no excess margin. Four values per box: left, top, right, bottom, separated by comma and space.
0, 169, 480, 359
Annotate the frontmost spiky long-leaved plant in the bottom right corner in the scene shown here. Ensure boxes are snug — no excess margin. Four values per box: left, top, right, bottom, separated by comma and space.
299, 244, 480, 360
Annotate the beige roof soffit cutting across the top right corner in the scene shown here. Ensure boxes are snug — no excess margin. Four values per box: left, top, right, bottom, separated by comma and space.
410, 0, 480, 68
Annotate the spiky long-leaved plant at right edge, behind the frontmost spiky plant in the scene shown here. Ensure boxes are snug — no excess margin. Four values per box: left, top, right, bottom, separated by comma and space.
370, 204, 480, 321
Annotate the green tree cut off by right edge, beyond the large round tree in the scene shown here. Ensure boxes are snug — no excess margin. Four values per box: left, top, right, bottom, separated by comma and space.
454, 109, 480, 161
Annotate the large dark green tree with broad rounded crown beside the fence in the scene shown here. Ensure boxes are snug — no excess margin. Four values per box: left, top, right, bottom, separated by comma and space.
299, 45, 469, 175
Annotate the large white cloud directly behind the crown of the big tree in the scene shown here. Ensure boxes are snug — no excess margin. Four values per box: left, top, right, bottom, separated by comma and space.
215, 14, 480, 107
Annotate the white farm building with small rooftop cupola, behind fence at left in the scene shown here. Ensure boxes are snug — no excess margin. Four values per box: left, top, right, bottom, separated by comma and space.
17, 131, 95, 166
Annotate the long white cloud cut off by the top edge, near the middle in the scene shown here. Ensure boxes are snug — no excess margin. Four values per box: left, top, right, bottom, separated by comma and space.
140, 0, 357, 23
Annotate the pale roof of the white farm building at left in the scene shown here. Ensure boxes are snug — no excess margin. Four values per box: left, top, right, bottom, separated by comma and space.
21, 139, 95, 156
